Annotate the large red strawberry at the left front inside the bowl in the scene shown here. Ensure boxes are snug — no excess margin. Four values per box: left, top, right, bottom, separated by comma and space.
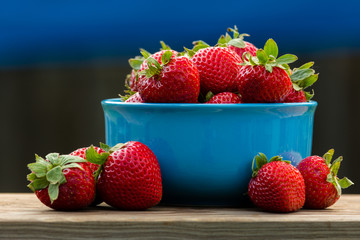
138, 50, 200, 103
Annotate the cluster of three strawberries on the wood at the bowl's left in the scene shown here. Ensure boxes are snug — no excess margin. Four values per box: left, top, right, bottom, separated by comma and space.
27, 141, 162, 211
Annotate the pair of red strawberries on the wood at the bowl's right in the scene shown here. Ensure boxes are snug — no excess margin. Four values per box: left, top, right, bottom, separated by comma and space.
248, 149, 353, 212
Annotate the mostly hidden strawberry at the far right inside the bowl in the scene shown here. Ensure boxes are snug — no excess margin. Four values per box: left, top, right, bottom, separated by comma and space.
283, 62, 319, 102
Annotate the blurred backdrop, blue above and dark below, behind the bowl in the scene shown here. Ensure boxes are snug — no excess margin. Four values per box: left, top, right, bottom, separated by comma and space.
0, 0, 360, 193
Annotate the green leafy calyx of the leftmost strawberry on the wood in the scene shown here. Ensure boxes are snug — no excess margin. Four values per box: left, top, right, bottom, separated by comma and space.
27, 153, 86, 203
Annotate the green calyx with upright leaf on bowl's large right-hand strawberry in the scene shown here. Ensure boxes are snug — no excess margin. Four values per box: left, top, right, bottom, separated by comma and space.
241, 38, 298, 75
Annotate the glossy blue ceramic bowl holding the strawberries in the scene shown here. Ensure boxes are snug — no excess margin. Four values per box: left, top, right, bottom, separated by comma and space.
102, 99, 317, 206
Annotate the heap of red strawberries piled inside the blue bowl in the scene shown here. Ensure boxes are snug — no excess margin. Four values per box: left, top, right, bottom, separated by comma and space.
122, 26, 318, 103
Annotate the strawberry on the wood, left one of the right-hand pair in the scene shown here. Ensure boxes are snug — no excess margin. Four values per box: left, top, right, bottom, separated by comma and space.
248, 153, 305, 212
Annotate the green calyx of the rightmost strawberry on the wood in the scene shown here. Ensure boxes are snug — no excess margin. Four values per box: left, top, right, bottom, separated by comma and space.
323, 149, 354, 196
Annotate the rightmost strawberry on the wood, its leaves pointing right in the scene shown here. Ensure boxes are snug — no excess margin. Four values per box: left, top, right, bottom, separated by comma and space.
297, 149, 353, 209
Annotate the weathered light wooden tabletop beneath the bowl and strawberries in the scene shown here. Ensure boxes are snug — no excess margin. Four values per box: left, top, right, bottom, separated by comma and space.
0, 193, 360, 240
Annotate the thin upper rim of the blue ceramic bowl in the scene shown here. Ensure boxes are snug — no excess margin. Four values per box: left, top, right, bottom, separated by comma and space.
101, 98, 318, 108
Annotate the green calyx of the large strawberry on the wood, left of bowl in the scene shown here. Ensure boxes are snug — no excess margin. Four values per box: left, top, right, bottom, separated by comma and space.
85, 143, 126, 182
